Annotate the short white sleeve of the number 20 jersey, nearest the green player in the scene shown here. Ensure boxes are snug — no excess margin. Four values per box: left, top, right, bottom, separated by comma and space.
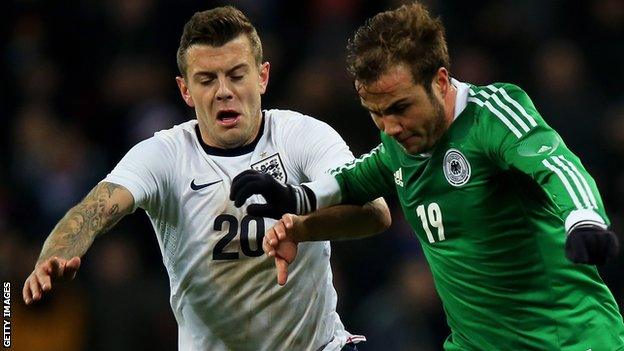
286, 116, 354, 181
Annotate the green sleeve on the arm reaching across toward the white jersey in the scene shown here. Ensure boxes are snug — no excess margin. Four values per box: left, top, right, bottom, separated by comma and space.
331, 144, 395, 204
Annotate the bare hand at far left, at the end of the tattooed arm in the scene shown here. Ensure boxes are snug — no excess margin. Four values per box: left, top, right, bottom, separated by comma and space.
22, 256, 80, 305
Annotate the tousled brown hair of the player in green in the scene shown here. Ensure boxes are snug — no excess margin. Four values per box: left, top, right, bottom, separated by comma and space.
347, 2, 450, 92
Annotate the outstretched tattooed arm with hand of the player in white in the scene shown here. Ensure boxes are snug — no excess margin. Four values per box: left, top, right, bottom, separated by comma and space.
22, 182, 134, 304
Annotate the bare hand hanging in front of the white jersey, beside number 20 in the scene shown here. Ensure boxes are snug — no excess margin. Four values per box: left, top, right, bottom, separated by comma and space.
262, 214, 298, 285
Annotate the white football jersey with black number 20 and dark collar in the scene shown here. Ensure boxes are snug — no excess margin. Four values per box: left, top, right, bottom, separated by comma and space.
104, 110, 363, 351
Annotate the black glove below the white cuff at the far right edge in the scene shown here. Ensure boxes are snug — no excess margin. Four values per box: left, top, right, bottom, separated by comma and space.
565, 226, 619, 265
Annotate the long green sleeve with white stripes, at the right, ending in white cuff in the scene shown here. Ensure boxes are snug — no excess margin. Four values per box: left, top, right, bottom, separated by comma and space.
468, 84, 609, 231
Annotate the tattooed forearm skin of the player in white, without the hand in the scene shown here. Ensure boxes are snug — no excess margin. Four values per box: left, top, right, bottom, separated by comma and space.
37, 182, 127, 263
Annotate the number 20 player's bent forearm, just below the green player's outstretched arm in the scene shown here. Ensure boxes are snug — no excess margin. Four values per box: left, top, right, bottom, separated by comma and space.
294, 198, 391, 242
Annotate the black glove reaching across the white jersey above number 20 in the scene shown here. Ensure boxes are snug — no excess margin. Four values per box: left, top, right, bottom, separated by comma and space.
230, 169, 316, 219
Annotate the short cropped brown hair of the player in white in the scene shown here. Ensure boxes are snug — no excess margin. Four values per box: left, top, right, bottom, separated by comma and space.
176, 6, 262, 77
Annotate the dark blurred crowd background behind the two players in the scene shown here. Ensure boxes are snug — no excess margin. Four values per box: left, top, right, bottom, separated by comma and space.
0, 0, 624, 351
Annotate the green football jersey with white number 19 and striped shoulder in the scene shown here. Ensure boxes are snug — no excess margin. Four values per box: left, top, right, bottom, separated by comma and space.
326, 81, 624, 351
